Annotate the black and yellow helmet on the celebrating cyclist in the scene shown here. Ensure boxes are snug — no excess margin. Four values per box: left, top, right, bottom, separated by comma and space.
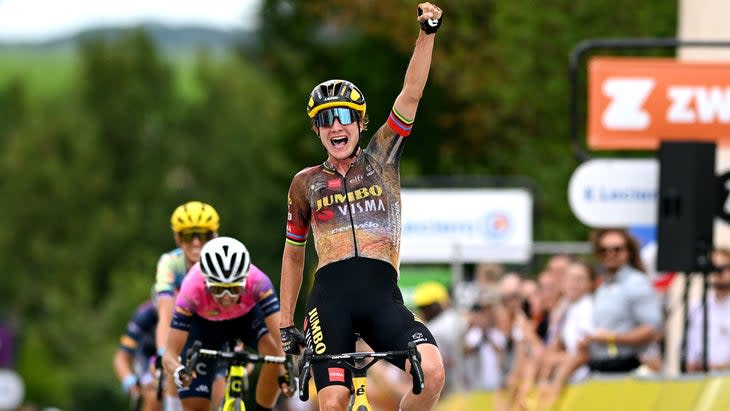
307, 80, 366, 118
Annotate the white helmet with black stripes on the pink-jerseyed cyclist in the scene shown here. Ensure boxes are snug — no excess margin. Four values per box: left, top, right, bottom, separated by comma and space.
200, 237, 251, 284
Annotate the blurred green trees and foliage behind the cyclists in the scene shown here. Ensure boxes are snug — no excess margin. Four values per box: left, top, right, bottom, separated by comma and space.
0, 0, 677, 410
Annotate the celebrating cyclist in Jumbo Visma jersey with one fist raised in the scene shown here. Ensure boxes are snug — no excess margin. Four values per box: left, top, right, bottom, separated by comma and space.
280, 3, 444, 411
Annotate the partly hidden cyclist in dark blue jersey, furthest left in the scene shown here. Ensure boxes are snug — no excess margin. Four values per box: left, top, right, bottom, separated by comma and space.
114, 300, 162, 411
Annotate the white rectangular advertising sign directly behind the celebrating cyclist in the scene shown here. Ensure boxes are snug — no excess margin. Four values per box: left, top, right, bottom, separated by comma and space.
400, 188, 532, 263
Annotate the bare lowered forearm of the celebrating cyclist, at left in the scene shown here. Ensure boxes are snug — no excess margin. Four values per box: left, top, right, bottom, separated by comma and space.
279, 244, 304, 328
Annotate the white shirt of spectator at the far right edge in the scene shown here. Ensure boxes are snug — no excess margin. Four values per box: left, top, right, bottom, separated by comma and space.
687, 290, 730, 368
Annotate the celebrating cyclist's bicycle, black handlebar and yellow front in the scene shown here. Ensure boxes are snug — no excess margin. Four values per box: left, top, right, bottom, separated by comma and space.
298, 342, 424, 411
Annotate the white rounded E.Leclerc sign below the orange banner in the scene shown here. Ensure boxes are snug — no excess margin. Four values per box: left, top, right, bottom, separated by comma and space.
568, 159, 659, 227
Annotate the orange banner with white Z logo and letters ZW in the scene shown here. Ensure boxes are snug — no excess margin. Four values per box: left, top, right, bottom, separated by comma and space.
587, 57, 730, 150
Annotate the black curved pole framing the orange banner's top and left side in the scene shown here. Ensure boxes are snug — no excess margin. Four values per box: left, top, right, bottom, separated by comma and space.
568, 37, 730, 163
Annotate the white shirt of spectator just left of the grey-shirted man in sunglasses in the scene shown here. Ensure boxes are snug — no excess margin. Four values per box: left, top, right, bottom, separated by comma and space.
560, 294, 594, 382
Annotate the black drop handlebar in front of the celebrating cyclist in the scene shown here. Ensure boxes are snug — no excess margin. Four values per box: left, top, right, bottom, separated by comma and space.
298, 341, 425, 401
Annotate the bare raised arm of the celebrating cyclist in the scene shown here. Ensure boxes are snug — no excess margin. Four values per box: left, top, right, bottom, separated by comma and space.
393, 3, 442, 120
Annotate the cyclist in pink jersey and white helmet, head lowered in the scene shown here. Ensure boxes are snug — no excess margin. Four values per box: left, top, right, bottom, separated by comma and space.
163, 237, 286, 411
